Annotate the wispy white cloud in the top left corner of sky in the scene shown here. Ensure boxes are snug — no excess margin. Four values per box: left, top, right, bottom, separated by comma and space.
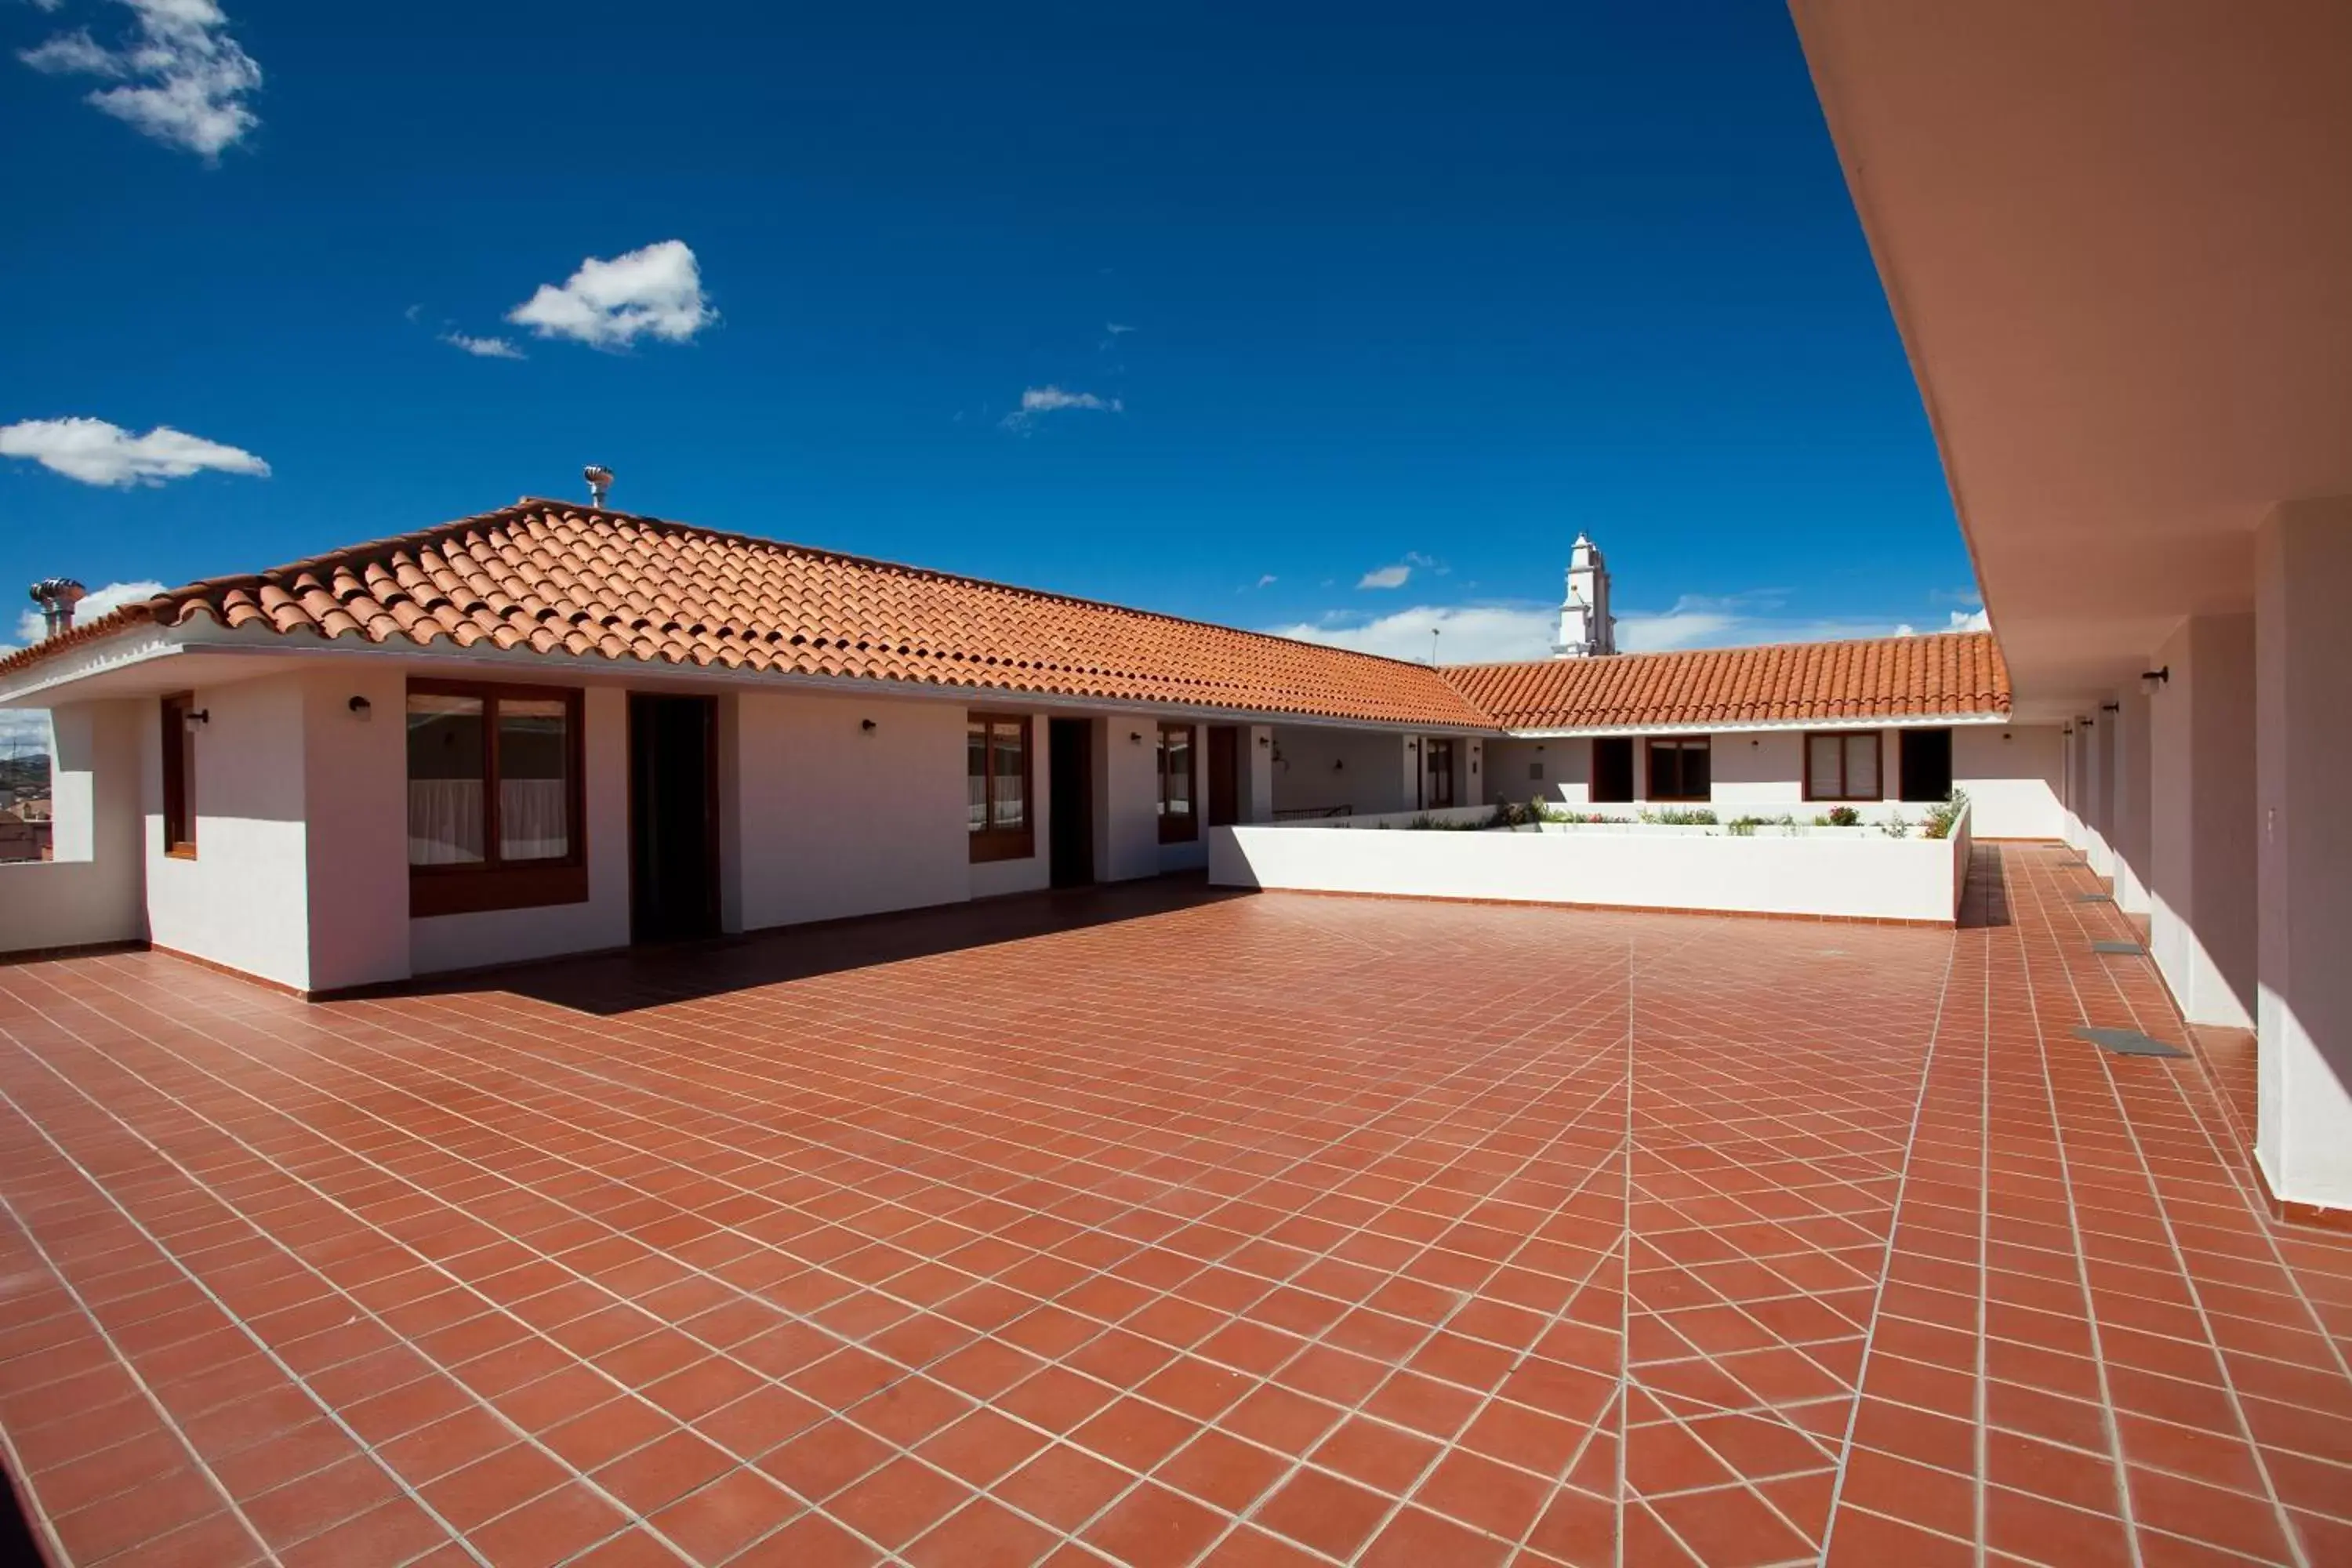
16, 0, 261, 162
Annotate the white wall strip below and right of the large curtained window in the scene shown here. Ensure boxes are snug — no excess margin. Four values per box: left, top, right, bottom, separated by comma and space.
397, 687, 628, 975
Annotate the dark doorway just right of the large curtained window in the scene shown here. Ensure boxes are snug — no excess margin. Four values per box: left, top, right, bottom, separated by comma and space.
628, 691, 720, 942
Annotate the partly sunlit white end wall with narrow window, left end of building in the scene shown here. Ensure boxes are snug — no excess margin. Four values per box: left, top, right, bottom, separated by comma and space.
141, 675, 310, 989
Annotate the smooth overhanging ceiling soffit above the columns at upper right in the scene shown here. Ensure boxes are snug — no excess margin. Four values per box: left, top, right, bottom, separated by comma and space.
1790, 0, 2352, 703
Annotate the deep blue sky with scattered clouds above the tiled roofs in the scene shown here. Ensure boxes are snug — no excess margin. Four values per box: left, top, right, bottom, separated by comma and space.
0, 0, 1973, 695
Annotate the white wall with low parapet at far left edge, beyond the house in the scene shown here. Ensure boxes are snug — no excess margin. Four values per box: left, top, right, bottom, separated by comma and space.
0, 701, 155, 954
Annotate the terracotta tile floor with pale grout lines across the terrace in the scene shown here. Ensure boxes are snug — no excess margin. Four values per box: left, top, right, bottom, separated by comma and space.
0, 846, 2352, 1568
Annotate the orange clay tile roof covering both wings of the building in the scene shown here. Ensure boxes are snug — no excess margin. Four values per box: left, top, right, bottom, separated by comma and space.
0, 501, 2009, 729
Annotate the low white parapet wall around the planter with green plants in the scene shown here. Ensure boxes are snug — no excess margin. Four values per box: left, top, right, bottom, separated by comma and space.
1209, 813, 1969, 924
